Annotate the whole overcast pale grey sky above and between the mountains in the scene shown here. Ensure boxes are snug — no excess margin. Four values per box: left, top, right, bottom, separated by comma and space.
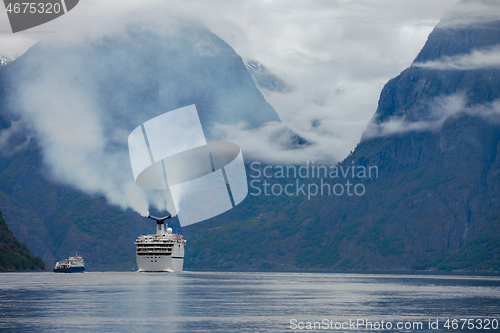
0, 0, 456, 163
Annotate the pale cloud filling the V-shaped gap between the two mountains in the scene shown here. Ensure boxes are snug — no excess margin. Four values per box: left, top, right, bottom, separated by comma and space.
200, 0, 456, 164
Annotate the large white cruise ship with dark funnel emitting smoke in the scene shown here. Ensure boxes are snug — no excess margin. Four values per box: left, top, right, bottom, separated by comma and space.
134, 215, 186, 272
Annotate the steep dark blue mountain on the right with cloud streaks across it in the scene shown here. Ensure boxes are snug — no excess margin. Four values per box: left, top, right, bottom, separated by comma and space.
185, 2, 500, 271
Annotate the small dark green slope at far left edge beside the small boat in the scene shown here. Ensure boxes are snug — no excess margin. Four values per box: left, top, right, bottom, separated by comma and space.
0, 212, 47, 271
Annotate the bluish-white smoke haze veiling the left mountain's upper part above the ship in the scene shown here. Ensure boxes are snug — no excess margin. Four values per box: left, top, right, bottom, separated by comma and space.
0, 16, 279, 215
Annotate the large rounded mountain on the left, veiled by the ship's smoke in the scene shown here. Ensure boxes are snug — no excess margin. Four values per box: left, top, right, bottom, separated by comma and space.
0, 25, 279, 270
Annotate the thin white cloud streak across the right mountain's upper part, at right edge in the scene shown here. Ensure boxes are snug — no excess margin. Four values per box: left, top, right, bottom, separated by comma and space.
412, 46, 500, 70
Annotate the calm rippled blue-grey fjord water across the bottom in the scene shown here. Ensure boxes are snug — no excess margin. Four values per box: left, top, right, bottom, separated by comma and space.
0, 272, 500, 332
